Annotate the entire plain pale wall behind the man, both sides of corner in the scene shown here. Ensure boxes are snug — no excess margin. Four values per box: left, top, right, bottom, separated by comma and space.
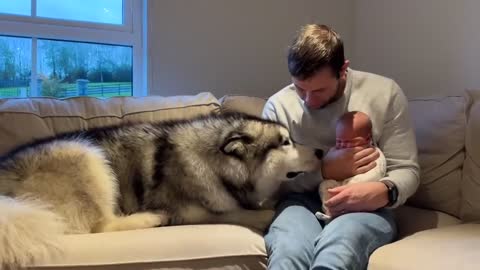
148, 0, 480, 97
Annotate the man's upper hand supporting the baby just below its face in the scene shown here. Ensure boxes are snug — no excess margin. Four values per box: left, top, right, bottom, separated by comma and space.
322, 146, 380, 181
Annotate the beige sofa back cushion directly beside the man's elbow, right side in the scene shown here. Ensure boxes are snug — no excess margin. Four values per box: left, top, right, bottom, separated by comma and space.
408, 96, 466, 217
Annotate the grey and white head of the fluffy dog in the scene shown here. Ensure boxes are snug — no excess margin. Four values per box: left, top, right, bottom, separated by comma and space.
221, 115, 321, 206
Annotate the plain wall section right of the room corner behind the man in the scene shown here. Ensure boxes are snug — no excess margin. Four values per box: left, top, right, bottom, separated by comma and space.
352, 0, 480, 97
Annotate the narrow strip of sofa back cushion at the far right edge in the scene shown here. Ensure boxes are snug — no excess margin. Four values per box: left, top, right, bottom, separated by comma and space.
461, 90, 480, 221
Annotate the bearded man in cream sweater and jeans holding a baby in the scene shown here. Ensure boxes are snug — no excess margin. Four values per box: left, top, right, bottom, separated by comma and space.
263, 24, 419, 270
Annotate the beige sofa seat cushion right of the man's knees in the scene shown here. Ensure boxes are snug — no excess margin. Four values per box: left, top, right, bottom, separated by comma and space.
368, 224, 480, 270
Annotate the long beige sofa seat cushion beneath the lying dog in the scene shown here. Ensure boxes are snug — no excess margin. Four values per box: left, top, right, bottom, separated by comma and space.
30, 225, 267, 270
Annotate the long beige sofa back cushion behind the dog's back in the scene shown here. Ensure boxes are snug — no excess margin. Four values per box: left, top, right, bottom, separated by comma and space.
0, 93, 220, 155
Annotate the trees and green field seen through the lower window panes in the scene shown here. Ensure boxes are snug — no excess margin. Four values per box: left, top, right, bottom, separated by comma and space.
0, 36, 132, 97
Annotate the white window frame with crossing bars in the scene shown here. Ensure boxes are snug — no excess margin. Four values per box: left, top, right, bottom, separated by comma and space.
0, 0, 147, 96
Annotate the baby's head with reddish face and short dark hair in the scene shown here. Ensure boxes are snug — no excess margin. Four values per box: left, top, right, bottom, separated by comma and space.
335, 111, 372, 148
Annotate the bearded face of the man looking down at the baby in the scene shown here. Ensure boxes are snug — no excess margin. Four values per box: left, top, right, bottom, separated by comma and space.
292, 64, 346, 109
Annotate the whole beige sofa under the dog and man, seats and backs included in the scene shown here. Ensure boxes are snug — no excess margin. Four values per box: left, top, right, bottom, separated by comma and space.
0, 91, 480, 270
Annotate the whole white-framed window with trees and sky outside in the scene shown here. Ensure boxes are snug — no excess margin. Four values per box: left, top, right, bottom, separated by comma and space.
0, 0, 146, 97
